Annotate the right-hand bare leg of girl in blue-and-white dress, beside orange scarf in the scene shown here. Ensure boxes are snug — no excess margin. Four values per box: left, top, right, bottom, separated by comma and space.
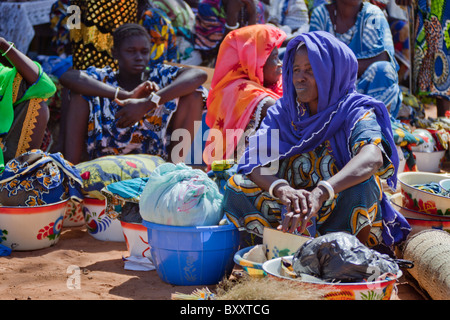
169, 91, 203, 162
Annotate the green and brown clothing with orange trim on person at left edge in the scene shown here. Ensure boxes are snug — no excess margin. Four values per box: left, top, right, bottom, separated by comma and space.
0, 62, 56, 172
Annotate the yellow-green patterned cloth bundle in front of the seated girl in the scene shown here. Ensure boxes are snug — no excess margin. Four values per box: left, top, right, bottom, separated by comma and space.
75, 154, 165, 199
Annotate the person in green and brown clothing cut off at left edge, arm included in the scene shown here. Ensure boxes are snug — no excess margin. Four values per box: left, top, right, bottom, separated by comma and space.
0, 37, 56, 173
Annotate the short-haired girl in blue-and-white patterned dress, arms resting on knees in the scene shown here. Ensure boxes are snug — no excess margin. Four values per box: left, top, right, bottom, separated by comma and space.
60, 24, 207, 164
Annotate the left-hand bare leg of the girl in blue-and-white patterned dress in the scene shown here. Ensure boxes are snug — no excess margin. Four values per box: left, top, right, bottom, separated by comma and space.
61, 94, 89, 164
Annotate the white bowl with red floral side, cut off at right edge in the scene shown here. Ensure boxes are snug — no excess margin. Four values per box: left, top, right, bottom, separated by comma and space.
398, 172, 450, 217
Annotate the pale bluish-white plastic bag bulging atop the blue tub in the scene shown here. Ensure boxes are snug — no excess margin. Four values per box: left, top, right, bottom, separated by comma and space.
139, 163, 223, 226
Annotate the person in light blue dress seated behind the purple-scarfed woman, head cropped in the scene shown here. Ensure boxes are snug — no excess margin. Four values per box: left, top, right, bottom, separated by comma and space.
309, 0, 402, 118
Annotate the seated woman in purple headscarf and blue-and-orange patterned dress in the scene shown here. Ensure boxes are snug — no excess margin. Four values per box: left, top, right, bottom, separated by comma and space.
224, 31, 411, 251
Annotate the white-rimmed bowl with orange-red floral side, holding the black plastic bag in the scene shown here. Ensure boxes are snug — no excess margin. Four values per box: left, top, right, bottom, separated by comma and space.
263, 256, 402, 300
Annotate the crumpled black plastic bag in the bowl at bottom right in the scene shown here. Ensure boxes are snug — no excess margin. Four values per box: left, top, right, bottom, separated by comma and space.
292, 232, 399, 282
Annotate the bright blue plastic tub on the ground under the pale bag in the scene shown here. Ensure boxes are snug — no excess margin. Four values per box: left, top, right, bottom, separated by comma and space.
142, 220, 239, 286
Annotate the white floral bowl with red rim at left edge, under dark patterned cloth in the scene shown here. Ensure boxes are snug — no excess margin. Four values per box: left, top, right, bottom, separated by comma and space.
0, 199, 68, 251
